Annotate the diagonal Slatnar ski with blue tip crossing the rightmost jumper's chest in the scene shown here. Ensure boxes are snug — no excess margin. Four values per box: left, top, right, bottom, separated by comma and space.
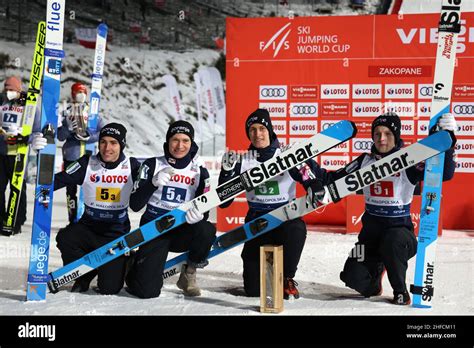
163, 131, 454, 279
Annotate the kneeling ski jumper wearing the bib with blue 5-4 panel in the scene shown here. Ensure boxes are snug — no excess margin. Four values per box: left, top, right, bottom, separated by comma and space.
126, 121, 216, 298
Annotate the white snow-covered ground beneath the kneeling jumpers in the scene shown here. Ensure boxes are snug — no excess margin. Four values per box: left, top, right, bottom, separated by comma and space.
0, 185, 474, 316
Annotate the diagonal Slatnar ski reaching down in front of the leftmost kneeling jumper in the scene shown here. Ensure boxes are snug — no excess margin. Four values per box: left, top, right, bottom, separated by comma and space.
48, 121, 357, 293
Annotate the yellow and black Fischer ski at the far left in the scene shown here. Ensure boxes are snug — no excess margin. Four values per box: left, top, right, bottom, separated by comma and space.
3, 22, 46, 235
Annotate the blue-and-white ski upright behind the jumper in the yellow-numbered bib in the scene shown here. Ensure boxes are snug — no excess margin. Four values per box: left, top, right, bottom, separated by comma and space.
76, 23, 109, 221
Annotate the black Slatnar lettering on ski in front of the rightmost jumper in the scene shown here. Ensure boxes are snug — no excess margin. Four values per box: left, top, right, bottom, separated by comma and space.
344, 152, 413, 192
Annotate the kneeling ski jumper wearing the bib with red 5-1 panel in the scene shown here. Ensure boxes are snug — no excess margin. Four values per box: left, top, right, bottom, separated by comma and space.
338, 113, 456, 305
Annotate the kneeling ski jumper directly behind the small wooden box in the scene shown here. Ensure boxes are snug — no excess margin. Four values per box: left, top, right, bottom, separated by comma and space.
219, 109, 327, 299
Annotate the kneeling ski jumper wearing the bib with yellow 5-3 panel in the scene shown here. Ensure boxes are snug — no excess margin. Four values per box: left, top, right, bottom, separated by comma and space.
33, 123, 140, 294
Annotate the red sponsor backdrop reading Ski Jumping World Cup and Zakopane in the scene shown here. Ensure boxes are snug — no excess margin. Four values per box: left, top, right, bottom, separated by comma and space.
223, 12, 474, 229
